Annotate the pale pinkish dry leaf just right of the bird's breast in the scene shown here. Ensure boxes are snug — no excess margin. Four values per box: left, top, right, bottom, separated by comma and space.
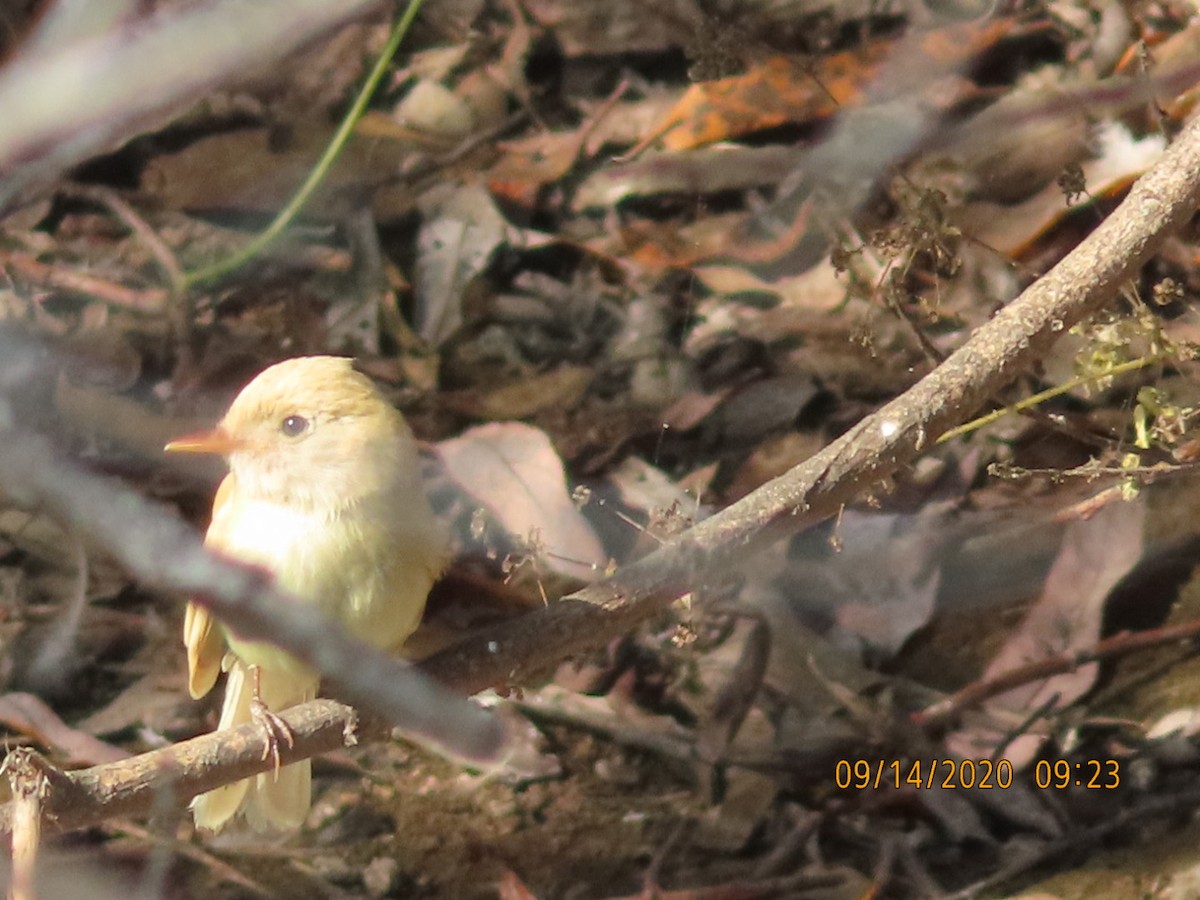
437, 422, 605, 581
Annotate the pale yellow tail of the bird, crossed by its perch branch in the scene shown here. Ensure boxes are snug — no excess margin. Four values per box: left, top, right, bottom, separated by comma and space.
192, 660, 317, 832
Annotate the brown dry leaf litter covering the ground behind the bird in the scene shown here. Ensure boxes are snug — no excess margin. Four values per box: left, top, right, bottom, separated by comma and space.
0, 0, 1200, 898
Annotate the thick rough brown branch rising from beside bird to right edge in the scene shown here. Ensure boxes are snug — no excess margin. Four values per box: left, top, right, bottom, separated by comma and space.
424, 105, 1200, 690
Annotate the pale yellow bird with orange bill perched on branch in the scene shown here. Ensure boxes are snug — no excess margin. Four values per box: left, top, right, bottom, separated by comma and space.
167, 356, 446, 830
